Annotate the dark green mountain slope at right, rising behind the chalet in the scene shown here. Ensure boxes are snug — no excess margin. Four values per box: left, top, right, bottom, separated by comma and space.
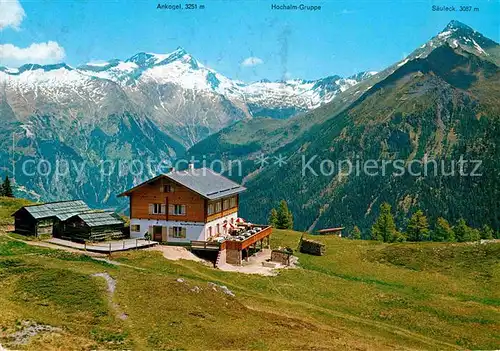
189, 22, 500, 233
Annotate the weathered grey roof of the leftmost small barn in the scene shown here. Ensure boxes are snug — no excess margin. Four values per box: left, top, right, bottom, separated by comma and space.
14, 200, 90, 221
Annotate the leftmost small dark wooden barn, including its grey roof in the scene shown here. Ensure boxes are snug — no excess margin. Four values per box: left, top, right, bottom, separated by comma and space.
12, 200, 90, 236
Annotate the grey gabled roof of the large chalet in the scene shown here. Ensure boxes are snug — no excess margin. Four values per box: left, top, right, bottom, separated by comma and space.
118, 168, 246, 200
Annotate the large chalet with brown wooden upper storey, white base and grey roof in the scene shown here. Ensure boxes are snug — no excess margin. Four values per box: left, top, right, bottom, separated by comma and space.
119, 168, 245, 244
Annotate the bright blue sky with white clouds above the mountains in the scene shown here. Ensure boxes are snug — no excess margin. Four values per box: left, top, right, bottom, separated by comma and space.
0, 0, 500, 82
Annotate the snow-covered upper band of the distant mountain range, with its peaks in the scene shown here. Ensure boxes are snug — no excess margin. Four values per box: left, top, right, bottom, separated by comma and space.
0, 47, 371, 129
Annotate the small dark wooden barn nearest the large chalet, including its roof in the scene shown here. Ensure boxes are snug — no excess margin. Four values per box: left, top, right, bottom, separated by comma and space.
62, 211, 125, 241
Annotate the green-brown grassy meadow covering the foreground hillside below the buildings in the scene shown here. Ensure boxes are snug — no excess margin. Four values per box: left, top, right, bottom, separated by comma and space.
0, 197, 500, 350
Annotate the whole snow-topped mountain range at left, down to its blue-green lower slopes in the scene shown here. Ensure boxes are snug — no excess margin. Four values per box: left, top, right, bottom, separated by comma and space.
0, 48, 371, 207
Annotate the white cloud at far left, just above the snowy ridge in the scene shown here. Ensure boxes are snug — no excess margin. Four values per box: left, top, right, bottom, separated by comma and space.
0, 41, 66, 65
